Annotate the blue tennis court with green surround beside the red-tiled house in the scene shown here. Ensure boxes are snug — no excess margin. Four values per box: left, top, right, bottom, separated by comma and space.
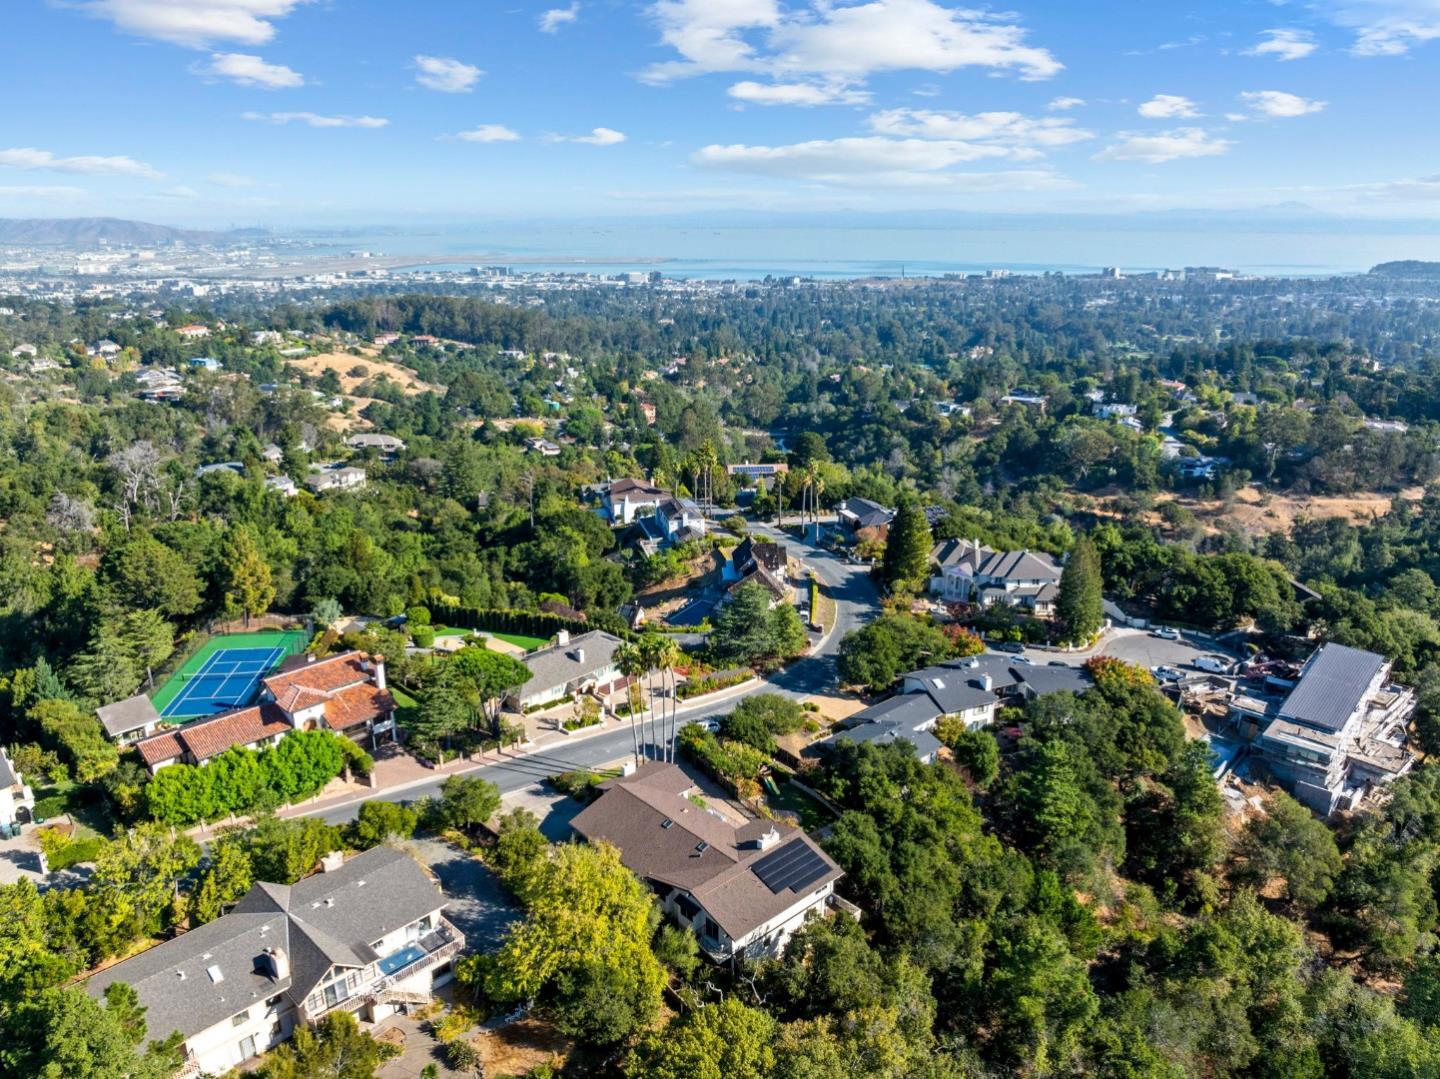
154, 631, 308, 720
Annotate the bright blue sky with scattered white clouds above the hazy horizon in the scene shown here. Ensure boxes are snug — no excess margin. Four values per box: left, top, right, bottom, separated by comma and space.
0, 0, 1440, 226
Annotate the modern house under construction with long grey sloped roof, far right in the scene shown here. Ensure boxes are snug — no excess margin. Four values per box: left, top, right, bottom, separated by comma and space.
1233, 644, 1416, 817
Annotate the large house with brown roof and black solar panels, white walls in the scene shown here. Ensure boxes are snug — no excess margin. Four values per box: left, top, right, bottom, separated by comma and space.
572, 761, 854, 962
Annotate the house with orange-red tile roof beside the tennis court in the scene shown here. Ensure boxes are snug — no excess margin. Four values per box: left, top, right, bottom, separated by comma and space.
134, 651, 395, 775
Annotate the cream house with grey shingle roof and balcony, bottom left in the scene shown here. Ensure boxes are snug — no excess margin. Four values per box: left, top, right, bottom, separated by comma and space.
86, 847, 465, 1079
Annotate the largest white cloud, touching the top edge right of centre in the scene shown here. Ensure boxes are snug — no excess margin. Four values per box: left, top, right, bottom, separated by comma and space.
642, 0, 1063, 82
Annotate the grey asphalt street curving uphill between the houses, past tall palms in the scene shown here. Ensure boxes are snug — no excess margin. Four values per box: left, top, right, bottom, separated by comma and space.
297, 524, 878, 824
